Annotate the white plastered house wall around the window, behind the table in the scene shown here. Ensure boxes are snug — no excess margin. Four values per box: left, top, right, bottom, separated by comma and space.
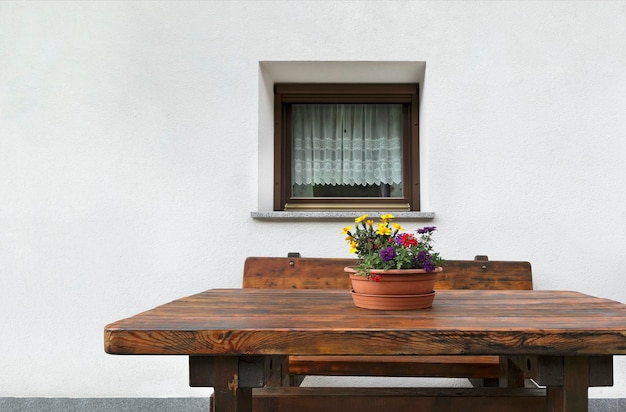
0, 1, 626, 397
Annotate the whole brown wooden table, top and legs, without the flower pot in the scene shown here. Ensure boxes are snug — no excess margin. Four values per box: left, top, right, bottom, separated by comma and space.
104, 289, 626, 412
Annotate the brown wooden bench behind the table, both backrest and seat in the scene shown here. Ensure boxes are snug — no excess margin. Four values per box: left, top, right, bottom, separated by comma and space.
243, 256, 532, 387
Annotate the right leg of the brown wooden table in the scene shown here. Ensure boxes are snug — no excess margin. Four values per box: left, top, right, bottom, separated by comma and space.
546, 356, 589, 412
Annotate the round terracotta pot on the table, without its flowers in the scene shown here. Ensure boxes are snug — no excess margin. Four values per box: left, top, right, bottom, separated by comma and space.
344, 267, 443, 310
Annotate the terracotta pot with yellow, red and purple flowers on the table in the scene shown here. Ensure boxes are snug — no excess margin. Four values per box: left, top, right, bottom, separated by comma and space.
343, 214, 445, 309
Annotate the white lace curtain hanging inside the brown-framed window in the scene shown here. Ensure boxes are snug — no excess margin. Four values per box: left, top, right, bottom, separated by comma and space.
292, 103, 402, 185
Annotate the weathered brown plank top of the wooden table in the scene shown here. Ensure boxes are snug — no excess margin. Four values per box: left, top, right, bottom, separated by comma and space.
105, 289, 626, 356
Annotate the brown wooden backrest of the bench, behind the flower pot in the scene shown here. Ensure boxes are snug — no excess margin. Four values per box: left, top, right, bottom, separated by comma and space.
243, 256, 533, 290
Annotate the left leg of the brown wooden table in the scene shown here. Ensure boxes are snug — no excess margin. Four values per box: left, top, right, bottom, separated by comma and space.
214, 356, 252, 412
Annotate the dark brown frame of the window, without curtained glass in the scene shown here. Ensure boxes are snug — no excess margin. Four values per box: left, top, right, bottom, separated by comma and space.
274, 83, 420, 211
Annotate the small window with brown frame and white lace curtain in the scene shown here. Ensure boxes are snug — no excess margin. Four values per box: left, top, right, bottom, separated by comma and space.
274, 84, 420, 210
